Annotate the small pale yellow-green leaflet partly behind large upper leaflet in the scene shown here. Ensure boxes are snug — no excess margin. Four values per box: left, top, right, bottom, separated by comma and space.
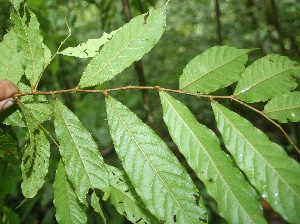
60, 29, 120, 58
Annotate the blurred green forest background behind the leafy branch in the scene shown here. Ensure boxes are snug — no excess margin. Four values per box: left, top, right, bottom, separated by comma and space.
0, 0, 300, 223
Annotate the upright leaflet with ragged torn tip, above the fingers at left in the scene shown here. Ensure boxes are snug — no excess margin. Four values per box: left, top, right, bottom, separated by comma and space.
11, 10, 49, 86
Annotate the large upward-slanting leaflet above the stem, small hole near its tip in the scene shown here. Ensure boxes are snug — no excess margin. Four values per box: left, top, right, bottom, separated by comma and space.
78, 9, 166, 87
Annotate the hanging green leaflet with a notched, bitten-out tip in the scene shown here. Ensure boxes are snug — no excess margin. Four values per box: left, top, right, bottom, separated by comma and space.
54, 100, 109, 203
